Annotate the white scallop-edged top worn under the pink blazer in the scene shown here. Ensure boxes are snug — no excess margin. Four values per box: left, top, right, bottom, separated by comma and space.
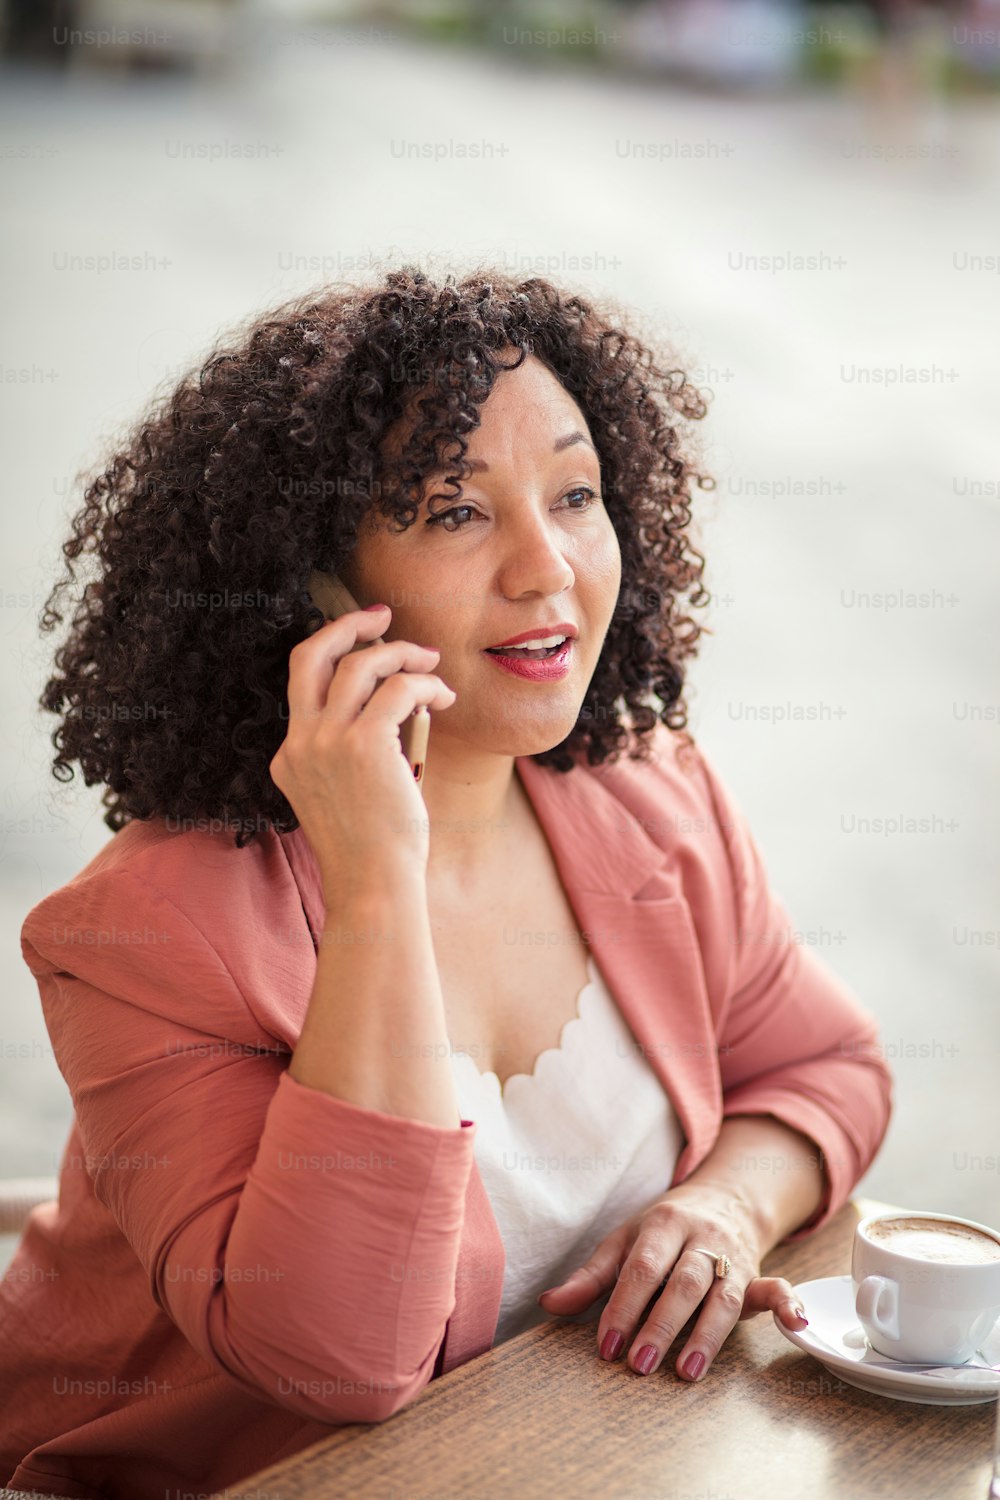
451, 953, 684, 1344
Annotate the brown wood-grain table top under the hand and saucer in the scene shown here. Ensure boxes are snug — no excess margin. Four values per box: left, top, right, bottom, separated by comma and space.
211, 1199, 997, 1500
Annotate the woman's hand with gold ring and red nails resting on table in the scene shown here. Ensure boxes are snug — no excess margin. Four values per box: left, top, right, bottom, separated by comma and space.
538, 1182, 807, 1380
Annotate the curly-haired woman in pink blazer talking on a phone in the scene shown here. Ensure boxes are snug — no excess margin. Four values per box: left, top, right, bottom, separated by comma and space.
0, 269, 889, 1500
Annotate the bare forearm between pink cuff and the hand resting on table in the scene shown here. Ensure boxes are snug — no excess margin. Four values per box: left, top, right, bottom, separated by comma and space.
673, 1115, 826, 1256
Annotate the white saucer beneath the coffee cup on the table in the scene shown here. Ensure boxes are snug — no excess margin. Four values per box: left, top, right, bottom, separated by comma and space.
774, 1277, 1000, 1406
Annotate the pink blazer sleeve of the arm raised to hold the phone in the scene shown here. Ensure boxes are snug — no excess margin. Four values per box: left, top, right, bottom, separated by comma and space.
21, 870, 475, 1424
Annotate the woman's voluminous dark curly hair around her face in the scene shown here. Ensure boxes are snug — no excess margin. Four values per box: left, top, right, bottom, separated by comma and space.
39, 266, 712, 848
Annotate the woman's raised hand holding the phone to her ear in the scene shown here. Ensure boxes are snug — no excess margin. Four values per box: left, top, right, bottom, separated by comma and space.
270, 606, 456, 909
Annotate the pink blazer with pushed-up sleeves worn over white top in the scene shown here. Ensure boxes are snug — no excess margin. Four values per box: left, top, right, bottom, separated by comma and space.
0, 729, 891, 1500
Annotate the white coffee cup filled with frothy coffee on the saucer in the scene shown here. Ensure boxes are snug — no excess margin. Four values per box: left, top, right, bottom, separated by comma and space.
850, 1211, 1000, 1365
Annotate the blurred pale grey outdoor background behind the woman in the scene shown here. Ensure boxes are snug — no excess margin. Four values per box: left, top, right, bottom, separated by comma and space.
0, 0, 1000, 1278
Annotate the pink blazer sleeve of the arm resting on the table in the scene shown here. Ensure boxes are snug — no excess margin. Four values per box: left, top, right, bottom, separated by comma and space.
699, 752, 892, 1244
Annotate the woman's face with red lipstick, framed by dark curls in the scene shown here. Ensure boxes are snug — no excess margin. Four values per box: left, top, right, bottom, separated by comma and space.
340, 357, 621, 756
